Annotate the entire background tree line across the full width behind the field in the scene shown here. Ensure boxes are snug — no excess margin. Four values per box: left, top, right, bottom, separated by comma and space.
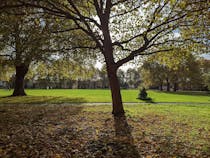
0, 50, 210, 91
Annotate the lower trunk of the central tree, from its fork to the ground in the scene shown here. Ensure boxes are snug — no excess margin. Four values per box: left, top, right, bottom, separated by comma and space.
107, 66, 125, 116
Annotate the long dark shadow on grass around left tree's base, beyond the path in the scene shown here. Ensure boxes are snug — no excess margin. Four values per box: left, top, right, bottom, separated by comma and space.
0, 96, 87, 104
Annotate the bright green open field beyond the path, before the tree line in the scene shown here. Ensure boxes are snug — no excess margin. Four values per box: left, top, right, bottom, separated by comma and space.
0, 89, 210, 103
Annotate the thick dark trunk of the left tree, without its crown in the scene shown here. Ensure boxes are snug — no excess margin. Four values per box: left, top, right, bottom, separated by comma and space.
12, 64, 28, 96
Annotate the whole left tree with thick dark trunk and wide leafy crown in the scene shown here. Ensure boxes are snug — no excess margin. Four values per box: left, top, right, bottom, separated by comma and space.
0, 8, 92, 96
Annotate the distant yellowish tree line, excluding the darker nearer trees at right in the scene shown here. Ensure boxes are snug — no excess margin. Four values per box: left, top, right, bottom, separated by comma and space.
0, 59, 141, 89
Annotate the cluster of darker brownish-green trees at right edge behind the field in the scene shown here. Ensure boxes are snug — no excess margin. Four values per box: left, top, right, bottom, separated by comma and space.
141, 50, 210, 92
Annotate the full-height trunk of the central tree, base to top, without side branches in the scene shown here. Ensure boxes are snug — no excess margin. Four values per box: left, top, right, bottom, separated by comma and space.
98, 11, 125, 116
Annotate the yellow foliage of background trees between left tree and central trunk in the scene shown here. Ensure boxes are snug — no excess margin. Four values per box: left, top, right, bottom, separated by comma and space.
26, 58, 95, 88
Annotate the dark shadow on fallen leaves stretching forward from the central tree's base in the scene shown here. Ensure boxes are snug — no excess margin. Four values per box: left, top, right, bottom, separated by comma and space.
88, 115, 141, 158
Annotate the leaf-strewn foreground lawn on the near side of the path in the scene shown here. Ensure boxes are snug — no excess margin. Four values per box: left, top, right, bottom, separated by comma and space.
0, 103, 210, 158
